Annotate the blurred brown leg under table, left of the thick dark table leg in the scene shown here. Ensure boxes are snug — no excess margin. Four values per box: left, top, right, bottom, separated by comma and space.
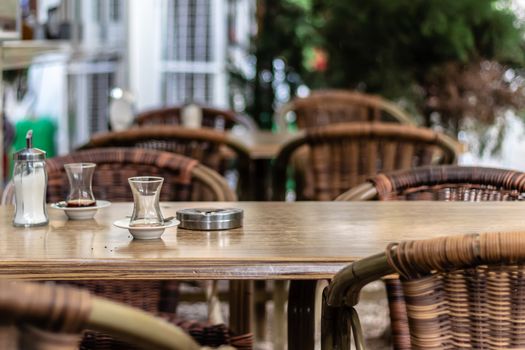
230, 280, 253, 334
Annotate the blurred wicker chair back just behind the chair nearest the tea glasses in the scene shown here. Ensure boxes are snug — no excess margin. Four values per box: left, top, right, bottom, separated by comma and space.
81, 125, 250, 200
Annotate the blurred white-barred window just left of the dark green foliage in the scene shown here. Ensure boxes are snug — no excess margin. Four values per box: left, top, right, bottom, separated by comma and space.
161, 0, 223, 105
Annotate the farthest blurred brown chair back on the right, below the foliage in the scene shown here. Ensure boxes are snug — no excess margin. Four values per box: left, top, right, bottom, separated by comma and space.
277, 90, 415, 130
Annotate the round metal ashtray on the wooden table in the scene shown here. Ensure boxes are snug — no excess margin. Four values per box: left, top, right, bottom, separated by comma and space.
177, 208, 244, 231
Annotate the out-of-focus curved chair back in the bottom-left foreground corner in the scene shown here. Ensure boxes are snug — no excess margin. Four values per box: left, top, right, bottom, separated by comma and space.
0, 280, 200, 350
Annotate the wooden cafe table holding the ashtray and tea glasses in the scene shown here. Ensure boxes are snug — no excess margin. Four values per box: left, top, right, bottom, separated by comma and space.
0, 201, 525, 349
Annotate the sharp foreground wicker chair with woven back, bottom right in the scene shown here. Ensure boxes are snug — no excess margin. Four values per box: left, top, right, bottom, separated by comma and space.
321, 232, 525, 350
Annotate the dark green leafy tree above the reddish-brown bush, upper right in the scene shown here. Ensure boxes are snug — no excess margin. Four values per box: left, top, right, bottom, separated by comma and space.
311, 0, 525, 98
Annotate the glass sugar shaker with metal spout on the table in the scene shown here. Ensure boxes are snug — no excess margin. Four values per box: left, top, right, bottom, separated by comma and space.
13, 130, 49, 227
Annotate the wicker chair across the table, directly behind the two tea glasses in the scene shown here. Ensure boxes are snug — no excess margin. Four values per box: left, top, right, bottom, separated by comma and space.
0, 148, 250, 349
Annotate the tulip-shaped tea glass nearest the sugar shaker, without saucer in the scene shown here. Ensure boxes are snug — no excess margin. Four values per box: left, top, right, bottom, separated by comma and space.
64, 163, 97, 208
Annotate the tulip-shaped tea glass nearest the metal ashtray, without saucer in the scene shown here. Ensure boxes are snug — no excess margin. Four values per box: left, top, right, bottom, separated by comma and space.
128, 176, 164, 227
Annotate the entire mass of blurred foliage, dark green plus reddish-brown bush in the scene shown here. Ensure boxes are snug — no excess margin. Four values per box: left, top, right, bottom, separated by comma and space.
233, 0, 525, 133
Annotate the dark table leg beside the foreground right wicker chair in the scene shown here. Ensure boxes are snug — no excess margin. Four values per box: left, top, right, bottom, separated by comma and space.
288, 280, 327, 350
